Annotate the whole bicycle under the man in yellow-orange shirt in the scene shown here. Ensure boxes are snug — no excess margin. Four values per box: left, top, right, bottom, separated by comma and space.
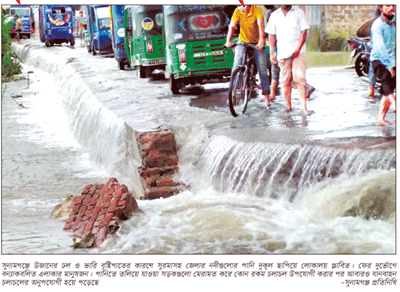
228, 43, 257, 117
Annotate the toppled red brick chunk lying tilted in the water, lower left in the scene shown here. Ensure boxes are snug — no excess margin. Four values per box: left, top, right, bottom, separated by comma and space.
64, 178, 140, 247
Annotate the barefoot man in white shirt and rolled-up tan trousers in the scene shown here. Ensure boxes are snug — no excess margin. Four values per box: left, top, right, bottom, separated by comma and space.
266, 5, 309, 114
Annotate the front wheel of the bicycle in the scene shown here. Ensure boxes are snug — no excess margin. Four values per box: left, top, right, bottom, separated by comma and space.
229, 67, 249, 117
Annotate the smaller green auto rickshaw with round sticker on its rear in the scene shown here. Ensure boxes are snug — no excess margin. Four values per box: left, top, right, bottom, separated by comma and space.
125, 5, 165, 78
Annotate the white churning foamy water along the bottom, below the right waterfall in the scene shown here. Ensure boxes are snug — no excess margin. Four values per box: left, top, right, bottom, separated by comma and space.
103, 172, 395, 254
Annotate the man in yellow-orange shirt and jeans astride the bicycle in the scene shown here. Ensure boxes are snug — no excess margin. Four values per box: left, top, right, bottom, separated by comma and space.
225, 5, 270, 107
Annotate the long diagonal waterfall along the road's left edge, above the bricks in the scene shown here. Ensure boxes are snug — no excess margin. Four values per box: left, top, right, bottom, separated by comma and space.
15, 45, 143, 197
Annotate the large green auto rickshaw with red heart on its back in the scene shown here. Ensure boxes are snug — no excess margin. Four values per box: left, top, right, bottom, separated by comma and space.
163, 5, 234, 94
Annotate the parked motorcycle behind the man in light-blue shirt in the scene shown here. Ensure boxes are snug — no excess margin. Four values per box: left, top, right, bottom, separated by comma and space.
347, 38, 371, 77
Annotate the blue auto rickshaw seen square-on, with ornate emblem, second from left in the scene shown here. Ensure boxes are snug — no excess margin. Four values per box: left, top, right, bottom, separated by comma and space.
39, 5, 75, 47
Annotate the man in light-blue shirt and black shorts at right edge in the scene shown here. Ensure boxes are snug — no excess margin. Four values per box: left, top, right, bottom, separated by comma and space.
370, 5, 396, 126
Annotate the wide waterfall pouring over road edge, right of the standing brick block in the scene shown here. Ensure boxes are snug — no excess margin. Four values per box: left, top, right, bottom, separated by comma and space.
200, 136, 396, 199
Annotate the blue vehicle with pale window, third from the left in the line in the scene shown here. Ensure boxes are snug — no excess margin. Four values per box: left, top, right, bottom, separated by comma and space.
86, 5, 113, 55
